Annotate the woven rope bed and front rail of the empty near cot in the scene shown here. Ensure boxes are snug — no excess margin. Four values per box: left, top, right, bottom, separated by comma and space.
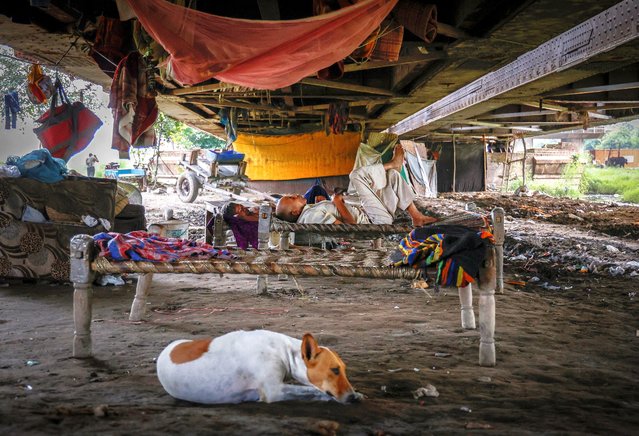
91, 247, 420, 280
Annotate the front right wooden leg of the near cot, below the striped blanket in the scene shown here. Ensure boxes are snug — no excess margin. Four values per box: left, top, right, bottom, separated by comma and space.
479, 247, 497, 366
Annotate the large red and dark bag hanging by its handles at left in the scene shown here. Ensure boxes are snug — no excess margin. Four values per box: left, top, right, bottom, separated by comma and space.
33, 79, 102, 162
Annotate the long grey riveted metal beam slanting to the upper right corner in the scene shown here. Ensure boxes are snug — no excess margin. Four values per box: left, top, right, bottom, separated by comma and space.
386, 0, 639, 135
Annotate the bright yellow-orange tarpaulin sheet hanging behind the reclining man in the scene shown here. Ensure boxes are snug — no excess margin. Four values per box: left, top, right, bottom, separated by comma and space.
233, 131, 361, 180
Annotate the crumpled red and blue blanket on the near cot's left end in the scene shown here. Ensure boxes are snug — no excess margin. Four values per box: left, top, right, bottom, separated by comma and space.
93, 231, 237, 262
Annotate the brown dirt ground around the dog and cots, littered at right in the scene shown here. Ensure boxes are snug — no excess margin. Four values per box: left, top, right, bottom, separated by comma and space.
0, 193, 639, 435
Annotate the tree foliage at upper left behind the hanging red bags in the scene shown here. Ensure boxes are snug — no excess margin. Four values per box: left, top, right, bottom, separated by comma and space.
0, 46, 103, 122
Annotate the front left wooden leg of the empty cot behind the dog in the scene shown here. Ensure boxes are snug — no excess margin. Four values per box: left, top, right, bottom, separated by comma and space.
70, 235, 95, 358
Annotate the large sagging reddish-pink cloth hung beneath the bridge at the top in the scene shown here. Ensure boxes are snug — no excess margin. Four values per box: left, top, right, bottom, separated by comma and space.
122, 0, 397, 89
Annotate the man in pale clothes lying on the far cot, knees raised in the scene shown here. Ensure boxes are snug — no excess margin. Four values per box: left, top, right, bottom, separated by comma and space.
275, 144, 437, 227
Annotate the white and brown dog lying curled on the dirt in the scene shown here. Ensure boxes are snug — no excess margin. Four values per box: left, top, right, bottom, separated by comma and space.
157, 330, 362, 404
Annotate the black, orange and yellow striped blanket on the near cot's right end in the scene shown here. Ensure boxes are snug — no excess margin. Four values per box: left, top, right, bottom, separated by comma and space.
390, 225, 493, 287
